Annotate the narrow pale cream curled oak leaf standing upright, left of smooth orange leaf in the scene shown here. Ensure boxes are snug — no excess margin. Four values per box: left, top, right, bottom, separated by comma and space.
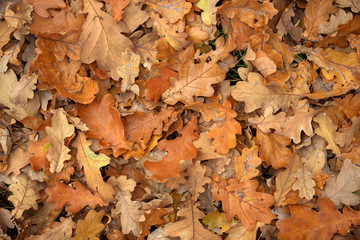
45, 109, 75, 173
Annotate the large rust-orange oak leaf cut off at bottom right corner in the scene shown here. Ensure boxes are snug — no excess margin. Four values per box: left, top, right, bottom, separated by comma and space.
276, 197, 360, 240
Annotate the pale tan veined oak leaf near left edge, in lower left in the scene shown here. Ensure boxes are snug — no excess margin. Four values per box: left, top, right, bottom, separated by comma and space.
8, 173, 42, 218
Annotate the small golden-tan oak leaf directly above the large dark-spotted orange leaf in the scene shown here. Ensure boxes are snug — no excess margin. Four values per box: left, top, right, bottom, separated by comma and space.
234, 146, 262, 182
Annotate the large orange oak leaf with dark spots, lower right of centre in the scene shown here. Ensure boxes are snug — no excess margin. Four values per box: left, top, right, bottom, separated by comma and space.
213, 176, 275, 230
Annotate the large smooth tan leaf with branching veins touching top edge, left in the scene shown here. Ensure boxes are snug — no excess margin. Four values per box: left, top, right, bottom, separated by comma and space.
80, 0, 133, 79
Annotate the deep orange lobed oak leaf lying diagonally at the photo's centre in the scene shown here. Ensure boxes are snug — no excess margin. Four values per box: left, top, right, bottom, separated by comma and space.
144, 118, 199, 182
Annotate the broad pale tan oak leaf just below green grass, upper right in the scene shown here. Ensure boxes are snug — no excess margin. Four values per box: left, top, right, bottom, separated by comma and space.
231, 72, 299, 113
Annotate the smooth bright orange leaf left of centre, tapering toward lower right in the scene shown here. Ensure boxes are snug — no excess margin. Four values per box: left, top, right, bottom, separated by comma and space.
78, 94, 131, 157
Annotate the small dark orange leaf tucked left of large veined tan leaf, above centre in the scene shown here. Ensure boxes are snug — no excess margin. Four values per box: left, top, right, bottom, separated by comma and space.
145, 67, 179, 103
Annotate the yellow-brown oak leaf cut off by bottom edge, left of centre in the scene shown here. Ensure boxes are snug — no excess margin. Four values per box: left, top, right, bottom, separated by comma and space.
70, 210, 105, 240
